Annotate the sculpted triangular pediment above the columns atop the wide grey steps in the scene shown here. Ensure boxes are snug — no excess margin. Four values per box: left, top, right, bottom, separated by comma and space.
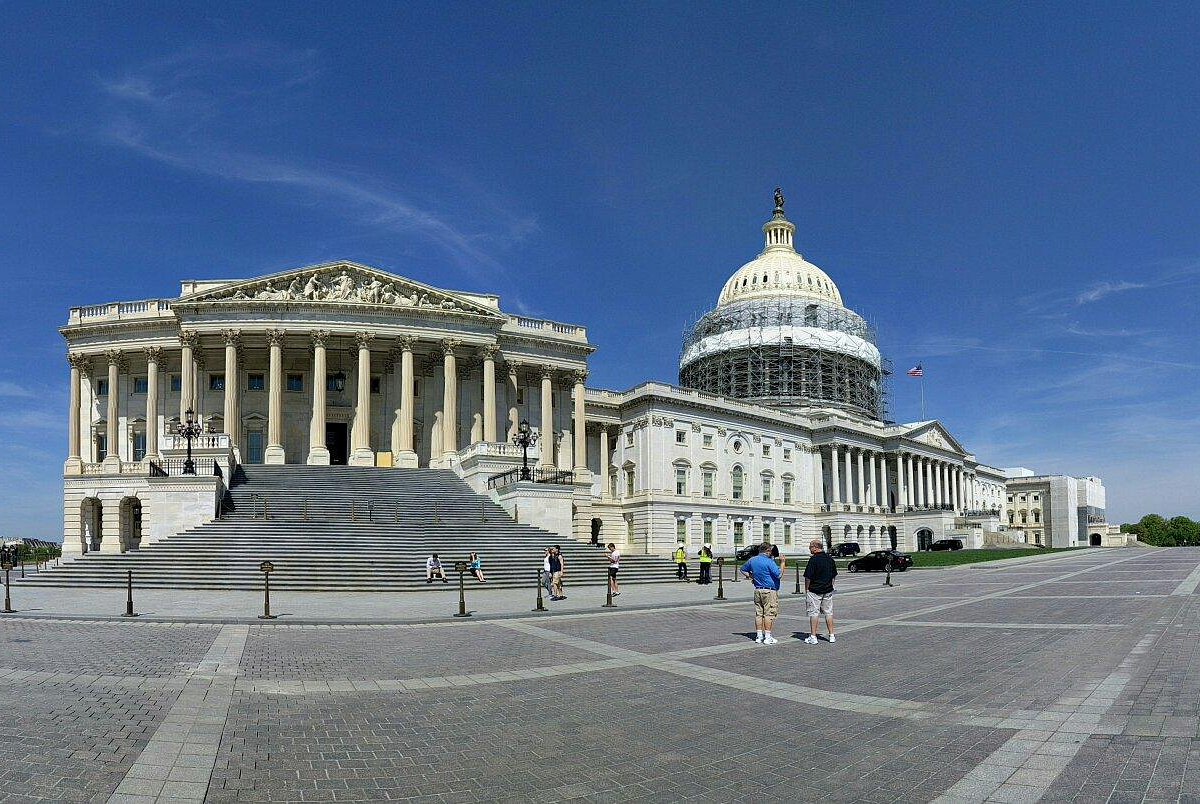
175, 262, 505, 319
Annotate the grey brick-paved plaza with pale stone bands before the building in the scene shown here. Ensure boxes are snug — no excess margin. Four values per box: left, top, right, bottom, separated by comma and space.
0, 548, 1200, 802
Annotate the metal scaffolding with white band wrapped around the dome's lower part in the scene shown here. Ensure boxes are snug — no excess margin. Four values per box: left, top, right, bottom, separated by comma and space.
679, 296, 892, 421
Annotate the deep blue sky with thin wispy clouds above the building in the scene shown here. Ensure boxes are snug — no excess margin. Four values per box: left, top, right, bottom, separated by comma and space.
0, 2, 1200, 536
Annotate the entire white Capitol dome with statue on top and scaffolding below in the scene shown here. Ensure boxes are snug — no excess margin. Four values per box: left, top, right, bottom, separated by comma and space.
679, 190, 889, 420
